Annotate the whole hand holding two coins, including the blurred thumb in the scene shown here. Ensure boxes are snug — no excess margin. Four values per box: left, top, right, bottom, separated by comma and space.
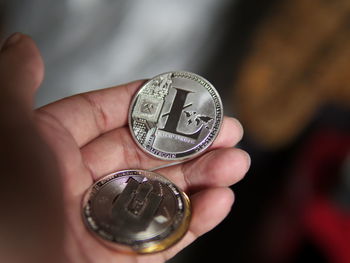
0, 35, 250, 263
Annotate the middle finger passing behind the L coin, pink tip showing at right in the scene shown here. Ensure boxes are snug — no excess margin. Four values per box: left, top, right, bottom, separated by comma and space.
81, 117, 243, 179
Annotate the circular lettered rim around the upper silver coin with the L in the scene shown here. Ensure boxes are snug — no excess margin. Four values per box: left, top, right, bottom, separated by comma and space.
128, 71, 224, 161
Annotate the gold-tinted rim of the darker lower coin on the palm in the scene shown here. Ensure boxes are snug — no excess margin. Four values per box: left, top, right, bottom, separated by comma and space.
81, 169, 192, 254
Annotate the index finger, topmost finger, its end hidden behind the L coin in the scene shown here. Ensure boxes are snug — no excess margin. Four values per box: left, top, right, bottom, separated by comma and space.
37, 80, 145, 147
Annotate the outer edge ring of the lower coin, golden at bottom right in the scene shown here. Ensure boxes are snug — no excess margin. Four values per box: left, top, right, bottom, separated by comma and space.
82, 170, 191, 254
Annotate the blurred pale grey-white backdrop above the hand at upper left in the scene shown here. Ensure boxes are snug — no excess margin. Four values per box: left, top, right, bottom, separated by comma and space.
5, 0, 232, 106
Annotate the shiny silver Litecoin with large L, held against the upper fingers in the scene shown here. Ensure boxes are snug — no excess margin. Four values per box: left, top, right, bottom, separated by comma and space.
129, 71, 223, 160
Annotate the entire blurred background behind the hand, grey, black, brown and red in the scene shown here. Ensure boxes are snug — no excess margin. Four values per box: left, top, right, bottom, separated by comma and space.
0, 0, 350, 263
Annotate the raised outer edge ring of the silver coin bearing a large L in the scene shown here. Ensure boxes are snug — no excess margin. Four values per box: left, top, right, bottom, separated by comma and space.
128, 71, 224, 161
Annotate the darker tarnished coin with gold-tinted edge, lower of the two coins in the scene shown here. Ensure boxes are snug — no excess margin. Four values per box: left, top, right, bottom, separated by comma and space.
82, 170, 191, 253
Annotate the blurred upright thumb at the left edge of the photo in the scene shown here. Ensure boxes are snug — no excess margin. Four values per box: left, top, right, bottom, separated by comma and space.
0, 33, 44, 107
